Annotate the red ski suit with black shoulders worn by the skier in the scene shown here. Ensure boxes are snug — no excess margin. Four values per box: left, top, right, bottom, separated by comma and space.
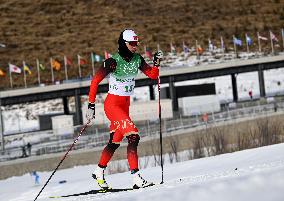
89, 56, 159, 170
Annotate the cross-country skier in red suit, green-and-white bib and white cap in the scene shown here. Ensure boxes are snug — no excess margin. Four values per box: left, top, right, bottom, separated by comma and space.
87, 29, 163, 189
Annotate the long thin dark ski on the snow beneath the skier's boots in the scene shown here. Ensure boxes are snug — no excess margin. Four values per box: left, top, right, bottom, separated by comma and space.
49, 184, 155, 198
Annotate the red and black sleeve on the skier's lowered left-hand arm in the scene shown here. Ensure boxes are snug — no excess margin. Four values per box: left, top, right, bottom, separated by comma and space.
89, 58, 116, 103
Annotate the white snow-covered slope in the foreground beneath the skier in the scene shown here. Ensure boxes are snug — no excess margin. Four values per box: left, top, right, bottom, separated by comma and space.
0, 144, 284, 201
